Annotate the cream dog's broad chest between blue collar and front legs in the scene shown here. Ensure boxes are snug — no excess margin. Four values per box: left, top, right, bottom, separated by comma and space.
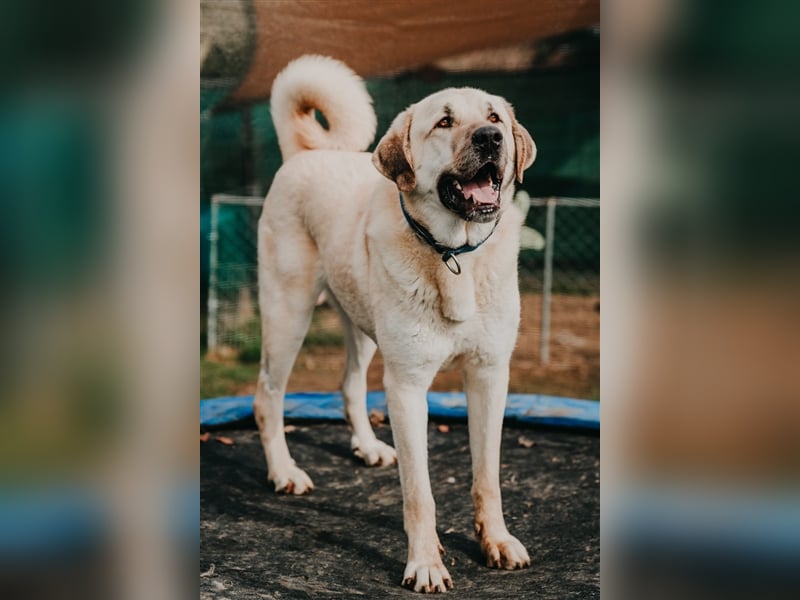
370, 216, 519, 365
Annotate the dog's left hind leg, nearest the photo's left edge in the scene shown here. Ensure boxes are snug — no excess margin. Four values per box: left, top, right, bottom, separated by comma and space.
253, 227, 322, 495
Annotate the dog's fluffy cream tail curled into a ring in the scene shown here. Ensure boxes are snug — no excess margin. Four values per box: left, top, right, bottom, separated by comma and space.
271, 54, 377, 161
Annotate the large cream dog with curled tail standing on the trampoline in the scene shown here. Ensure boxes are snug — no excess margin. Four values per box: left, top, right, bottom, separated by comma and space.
254, 56, 536, 592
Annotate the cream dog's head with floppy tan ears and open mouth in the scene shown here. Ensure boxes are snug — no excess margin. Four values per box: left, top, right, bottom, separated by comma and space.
372, 88, 536, 223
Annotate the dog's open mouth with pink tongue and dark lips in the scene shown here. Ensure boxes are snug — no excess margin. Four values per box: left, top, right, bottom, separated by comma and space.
439, 162, 503, 223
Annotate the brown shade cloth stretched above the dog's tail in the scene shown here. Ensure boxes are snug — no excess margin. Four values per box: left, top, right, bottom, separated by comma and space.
232, 0, 600, 101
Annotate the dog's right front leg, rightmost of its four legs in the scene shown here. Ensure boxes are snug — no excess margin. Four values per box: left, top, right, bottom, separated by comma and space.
464, 363, 531, 569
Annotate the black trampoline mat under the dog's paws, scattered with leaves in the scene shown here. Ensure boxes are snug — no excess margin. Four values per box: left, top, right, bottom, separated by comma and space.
200, 421, 600, 600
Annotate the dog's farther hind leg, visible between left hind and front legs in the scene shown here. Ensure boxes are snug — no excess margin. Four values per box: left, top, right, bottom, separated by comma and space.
339, 309, 397, 467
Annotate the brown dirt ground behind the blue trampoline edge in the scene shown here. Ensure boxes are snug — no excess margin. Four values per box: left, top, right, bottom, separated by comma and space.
222, 294, 600, 399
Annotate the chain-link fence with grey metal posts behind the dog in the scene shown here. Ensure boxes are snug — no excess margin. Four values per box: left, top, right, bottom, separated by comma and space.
207, 194, 600, 380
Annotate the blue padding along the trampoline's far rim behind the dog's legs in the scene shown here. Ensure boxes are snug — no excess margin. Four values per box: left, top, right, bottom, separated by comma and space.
200, 392, 600, 429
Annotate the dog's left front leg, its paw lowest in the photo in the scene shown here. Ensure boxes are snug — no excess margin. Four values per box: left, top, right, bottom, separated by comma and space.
384, 365, 453, 593
